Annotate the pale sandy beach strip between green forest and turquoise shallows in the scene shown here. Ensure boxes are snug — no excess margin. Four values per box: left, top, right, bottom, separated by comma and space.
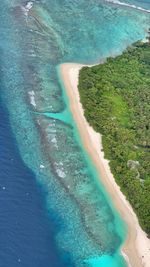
60, 63, 150, 267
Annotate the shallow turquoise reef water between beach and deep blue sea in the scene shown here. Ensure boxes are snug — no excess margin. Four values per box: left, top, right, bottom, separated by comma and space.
0, 0, 150, 267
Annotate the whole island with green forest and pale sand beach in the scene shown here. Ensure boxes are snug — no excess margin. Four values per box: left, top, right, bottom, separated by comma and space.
60, 39, 150, 267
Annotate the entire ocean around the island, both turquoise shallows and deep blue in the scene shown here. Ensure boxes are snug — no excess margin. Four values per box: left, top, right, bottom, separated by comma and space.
0, 0, 150, 267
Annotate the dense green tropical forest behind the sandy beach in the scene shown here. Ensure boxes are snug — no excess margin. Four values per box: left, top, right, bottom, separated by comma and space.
78, 39, 150, 237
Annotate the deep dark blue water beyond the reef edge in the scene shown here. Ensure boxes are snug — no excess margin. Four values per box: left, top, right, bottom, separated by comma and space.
0, 100, 66, 267
